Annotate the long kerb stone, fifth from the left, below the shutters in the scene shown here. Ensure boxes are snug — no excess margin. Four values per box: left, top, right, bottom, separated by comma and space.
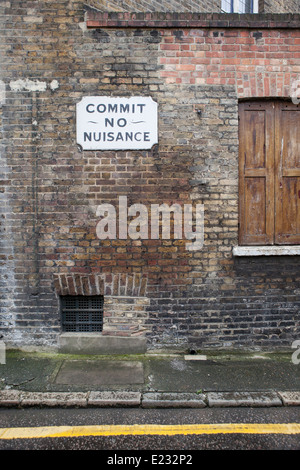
207, 392, 282, 407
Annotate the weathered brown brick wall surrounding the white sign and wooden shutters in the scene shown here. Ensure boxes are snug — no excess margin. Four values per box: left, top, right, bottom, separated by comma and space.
0, 0, 300, 348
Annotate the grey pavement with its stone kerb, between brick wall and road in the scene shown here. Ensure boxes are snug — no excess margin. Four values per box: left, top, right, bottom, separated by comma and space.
0, 350, 300, 408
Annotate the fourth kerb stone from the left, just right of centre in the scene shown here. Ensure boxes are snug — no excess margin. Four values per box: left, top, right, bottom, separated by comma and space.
142, 392, 206, 408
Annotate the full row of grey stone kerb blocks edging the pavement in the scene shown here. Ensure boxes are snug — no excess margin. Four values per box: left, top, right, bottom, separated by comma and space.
0, 389, 300, 408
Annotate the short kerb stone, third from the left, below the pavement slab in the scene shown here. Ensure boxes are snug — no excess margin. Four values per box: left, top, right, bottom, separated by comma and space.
88, 391, 141, 406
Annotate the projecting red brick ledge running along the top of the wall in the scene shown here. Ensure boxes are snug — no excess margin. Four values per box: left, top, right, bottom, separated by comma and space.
86, 8, 300, 29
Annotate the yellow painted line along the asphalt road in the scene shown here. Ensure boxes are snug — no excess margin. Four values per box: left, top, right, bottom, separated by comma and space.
0, 423, 300, 439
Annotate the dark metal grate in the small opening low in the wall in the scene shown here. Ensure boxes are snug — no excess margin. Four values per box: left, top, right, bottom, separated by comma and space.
61, 295, 104, 332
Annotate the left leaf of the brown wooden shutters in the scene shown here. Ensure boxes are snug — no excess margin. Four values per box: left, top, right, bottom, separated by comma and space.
239, 102, 274, 245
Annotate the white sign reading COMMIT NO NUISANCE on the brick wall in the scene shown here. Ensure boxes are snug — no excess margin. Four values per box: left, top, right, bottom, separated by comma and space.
76, 96, 158, 150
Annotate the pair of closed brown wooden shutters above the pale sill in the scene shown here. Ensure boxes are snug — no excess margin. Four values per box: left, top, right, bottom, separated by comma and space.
239, 101, 300, 245
